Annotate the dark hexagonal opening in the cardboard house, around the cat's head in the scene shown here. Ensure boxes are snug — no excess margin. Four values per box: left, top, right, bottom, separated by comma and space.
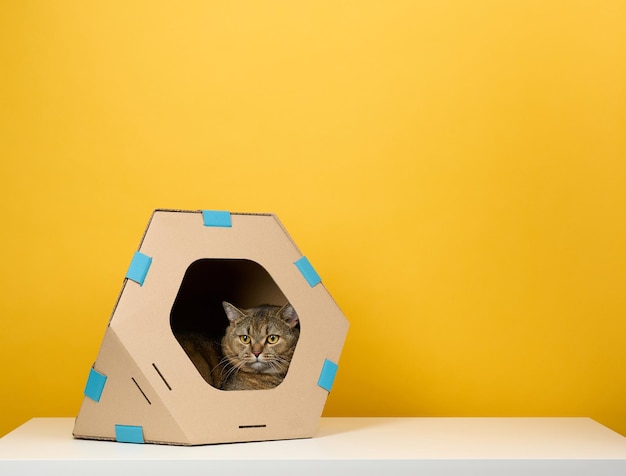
170, 258, 300, 390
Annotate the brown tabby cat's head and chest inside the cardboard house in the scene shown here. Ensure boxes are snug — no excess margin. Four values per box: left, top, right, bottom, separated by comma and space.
220, 302, 300, 390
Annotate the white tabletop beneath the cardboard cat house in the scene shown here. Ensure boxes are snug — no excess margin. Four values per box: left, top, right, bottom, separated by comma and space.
0, 418, 626, 476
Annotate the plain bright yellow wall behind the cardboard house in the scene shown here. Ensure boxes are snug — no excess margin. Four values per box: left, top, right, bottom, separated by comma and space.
0, 0, 626, 434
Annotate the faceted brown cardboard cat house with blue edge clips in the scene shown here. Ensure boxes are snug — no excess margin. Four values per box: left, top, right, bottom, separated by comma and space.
73, 210, 348, 445
